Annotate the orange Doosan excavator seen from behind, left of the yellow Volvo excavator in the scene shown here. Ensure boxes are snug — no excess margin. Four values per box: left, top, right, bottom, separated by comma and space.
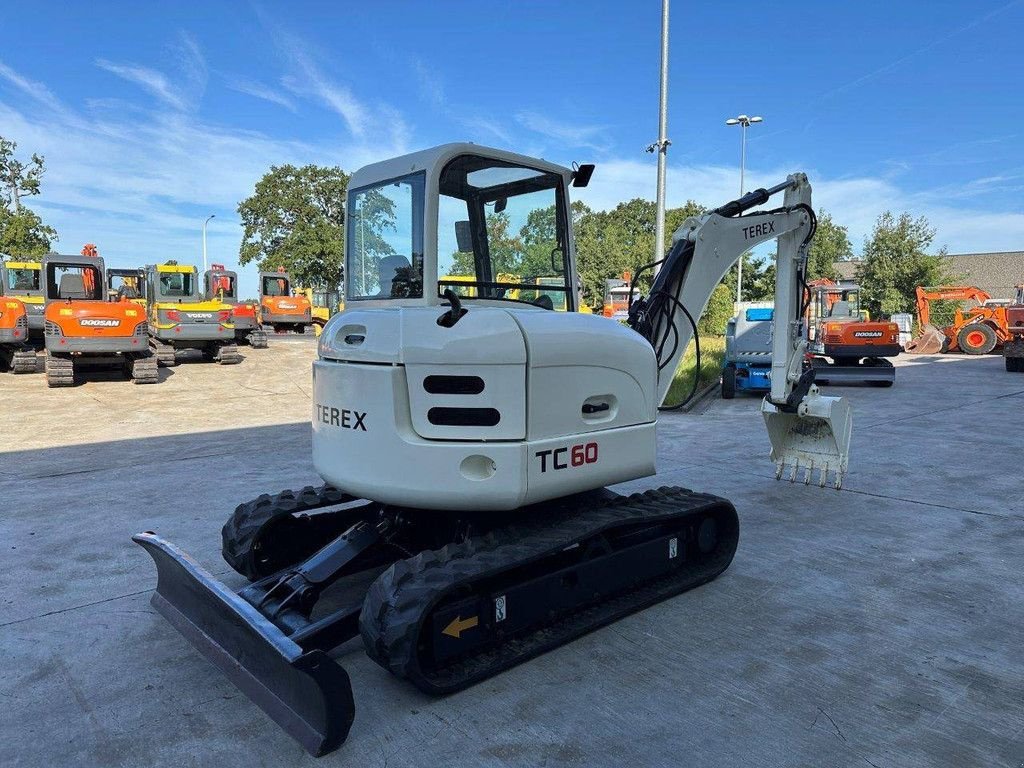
42, 249, 157, 387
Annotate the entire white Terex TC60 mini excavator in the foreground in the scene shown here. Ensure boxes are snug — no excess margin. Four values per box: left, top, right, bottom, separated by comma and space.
134, 143, 851, 755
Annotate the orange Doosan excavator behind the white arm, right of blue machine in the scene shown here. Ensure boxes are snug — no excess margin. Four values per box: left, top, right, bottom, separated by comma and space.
806, 278, 900, 387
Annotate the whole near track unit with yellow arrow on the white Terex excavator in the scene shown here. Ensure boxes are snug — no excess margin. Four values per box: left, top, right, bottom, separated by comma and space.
359, 487, 739, 693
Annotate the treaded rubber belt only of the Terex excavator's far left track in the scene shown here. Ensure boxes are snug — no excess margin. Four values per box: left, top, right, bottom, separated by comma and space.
220, 483, 364, 580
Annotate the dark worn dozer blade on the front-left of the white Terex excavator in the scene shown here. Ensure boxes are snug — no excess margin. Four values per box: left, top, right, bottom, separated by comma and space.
132, 531, 355, 756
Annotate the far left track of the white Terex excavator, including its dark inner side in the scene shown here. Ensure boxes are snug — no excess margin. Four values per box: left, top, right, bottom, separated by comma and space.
220, 484, 376, 581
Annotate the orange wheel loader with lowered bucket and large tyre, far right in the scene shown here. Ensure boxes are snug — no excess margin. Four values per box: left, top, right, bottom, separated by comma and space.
906, 286, 1012, 354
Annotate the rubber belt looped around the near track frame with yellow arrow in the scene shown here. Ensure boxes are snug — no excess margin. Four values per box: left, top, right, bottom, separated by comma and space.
359, 487, 738, 693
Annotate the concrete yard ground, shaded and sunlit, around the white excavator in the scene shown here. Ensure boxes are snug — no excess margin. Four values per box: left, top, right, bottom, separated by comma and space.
0, 350, 1024, 768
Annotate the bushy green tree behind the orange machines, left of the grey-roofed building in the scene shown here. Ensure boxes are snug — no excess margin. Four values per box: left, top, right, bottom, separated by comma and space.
857, 211, 956, 316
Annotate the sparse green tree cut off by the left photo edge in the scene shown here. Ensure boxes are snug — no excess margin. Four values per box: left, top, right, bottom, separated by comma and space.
0, 136, 57, 256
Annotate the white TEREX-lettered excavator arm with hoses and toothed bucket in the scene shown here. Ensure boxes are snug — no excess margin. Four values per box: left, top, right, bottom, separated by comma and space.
629, 173, 852, 488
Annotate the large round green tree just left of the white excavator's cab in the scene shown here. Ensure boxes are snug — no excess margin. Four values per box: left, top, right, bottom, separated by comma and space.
238, 165, 350, 288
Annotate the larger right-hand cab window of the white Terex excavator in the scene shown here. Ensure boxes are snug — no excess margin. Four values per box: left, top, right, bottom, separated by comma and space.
437, 155, 575, 310
